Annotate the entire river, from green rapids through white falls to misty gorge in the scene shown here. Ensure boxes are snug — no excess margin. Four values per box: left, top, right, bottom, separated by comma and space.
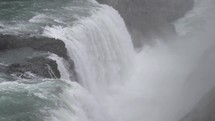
0, 0, 215, 121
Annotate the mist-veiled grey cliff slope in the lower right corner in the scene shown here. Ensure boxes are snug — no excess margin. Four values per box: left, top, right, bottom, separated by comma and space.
181, 45, 215, 121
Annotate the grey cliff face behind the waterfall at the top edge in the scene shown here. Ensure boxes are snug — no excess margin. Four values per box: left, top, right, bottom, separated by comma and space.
97, 0, 194, 47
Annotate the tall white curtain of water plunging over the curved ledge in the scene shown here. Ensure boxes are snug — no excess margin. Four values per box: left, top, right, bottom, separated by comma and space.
44, 5, 134, 94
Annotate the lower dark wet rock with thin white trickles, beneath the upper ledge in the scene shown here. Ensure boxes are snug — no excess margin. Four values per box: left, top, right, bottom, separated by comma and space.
4, 57, 61, 79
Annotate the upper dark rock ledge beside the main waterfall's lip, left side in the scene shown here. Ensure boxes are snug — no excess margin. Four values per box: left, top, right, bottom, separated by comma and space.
0, 34, 68, 59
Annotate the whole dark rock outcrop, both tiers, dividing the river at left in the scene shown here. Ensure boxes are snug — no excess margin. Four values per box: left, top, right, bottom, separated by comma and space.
0, 34, 77, 80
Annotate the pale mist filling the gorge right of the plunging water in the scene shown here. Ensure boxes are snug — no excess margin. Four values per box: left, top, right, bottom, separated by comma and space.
101, 0, 215, 121
